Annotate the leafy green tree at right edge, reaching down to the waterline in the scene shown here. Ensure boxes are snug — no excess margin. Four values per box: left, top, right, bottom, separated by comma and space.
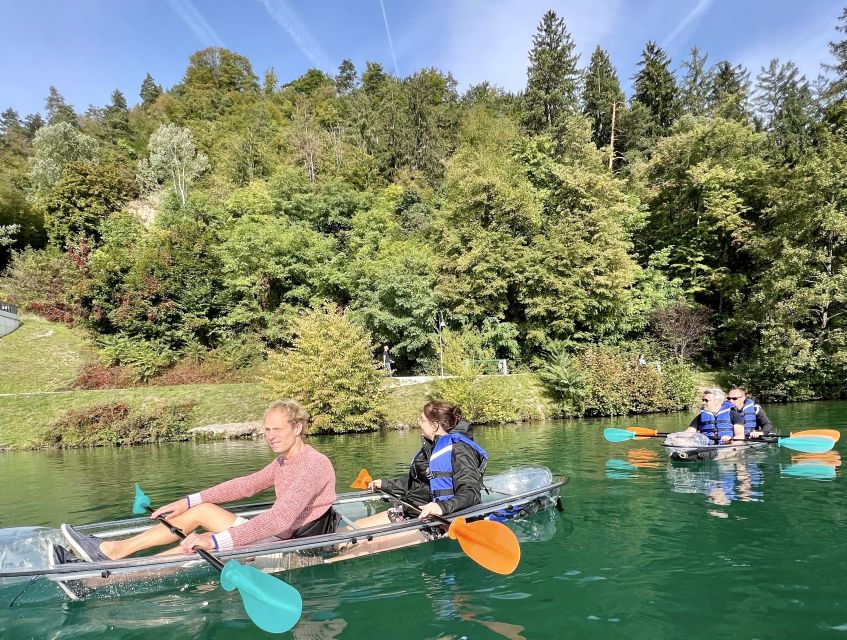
739, 135, 847, 400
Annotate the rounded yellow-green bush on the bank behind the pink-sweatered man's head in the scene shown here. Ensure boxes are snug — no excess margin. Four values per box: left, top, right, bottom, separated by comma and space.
264, 309, 385, 433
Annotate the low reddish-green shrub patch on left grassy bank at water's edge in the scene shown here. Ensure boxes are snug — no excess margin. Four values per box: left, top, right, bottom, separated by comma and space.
43, 402, 196, 448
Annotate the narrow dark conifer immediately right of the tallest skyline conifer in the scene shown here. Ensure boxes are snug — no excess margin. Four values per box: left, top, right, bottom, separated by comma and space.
582, 47, 624, 147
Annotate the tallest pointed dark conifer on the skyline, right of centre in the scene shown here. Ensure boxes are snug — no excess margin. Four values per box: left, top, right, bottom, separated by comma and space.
524, 10, 579, 133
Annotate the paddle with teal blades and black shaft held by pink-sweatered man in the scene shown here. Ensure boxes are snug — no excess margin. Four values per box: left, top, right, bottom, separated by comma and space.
132, 482, 303, 633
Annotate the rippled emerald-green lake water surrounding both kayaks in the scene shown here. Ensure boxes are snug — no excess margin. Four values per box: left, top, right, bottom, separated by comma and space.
0, 402, 847, 640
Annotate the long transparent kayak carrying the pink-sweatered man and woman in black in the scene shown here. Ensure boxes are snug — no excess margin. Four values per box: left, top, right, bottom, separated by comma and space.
0, 466, 569, 600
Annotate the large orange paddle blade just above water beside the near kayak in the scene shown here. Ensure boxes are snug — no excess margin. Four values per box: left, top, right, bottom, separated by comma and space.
447, 518, 521, 576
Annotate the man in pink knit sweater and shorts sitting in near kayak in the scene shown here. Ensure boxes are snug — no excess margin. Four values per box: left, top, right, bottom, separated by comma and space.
62, 400, 337, 562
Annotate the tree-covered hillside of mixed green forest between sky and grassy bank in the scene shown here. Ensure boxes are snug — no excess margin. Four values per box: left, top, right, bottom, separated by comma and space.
0, 10, 847, 402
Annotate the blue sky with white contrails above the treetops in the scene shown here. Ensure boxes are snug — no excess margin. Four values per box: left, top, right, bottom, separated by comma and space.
0, 0, 847, 116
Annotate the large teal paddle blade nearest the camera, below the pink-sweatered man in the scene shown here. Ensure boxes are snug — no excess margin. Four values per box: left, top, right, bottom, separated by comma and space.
221, 560, 303, 633
